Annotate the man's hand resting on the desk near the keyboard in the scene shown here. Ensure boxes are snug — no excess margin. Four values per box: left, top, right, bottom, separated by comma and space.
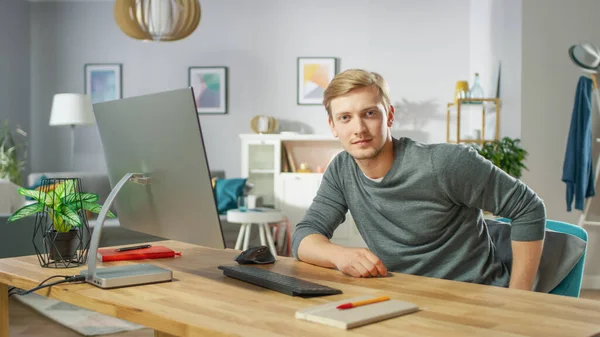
332, 248, 387, 277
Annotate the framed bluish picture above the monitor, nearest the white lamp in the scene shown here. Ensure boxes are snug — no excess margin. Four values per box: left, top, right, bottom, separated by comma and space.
83, 63, 123, 104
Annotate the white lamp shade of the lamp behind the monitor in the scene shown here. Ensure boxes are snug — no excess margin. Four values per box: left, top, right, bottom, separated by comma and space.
50, 94, 96, 125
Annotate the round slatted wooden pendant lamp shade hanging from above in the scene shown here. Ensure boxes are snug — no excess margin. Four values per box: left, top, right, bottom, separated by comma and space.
114, 0, 201, 41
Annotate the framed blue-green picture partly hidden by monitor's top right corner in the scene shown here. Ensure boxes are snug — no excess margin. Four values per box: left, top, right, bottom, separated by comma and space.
188, 67, 227, 114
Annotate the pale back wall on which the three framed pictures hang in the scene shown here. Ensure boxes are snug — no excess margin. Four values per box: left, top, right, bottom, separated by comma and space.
30, 0, 469, 177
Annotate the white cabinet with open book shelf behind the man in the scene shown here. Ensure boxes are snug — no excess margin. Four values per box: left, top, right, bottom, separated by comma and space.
240, 134, 366, 247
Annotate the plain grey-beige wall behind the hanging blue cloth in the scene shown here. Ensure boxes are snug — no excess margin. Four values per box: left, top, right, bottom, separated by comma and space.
521, 0, 600, 287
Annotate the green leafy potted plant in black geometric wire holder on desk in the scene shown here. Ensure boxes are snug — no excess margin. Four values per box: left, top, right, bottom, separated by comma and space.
8, 178, 115, 268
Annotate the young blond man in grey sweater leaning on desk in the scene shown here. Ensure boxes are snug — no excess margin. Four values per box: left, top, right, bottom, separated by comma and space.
292, 69, 546, 290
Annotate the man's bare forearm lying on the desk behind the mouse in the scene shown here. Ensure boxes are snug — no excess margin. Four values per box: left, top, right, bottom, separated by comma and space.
298, 234, 343, 268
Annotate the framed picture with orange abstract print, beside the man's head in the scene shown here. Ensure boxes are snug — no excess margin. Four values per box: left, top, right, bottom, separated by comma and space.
297, 57, 338, 105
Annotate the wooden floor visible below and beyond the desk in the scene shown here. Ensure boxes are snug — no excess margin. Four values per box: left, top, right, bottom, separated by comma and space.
9, 290, 600, 337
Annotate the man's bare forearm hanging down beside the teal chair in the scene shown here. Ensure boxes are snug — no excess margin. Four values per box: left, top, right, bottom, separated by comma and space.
508, 240, 544, 290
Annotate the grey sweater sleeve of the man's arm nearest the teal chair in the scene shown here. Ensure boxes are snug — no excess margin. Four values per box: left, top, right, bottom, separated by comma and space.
432, 144, 546, 241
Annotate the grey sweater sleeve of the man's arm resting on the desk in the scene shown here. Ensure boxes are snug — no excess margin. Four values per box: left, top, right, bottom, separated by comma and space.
292, 158, 348, 258
